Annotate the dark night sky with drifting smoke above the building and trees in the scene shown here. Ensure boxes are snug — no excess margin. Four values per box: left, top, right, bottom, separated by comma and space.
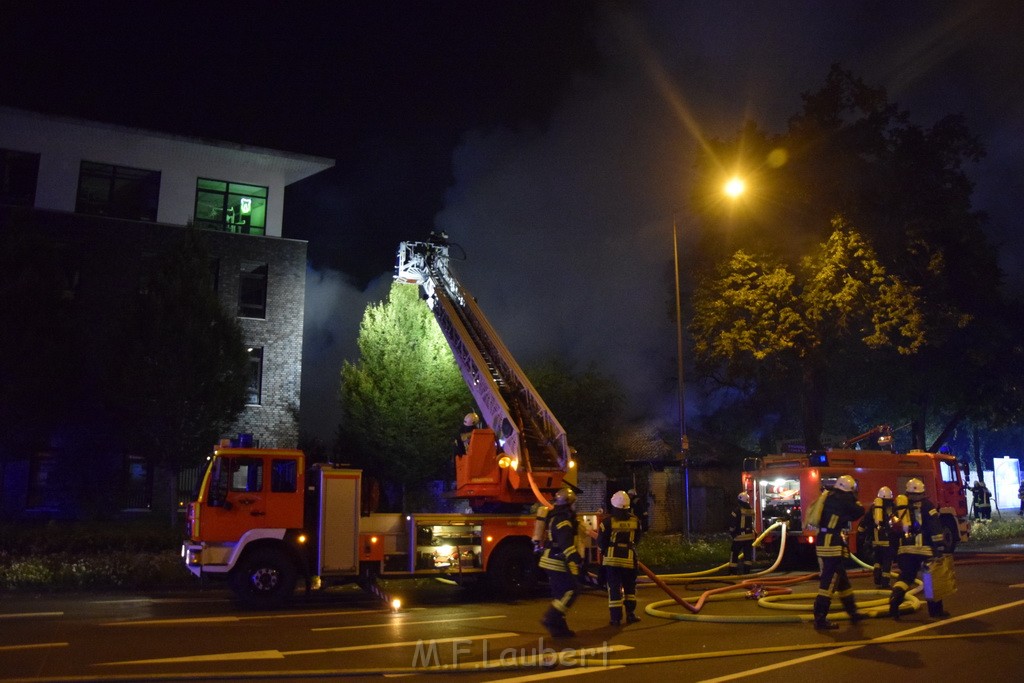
0, 0, 1024, 440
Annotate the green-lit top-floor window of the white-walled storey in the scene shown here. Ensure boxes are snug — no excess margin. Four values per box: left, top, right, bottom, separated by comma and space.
195, 178, 267, 234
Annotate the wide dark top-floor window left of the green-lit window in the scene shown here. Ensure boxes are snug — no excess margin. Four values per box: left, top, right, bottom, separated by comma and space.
75, 161, 160, 221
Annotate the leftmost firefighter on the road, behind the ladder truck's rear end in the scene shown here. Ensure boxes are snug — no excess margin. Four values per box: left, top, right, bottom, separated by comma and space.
539, 488, 583, 638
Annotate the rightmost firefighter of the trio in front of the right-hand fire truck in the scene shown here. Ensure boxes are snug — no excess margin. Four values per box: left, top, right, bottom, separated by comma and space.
889, 478, 949, 621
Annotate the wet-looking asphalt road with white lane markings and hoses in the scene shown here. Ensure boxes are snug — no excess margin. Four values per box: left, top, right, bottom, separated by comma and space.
0, 549, 1024, 683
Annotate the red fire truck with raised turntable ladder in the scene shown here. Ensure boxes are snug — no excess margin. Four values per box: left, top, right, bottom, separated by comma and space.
181, 236, 575, 604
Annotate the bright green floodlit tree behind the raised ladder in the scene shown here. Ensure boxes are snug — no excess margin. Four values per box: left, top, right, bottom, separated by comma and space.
340, 283, 473, 507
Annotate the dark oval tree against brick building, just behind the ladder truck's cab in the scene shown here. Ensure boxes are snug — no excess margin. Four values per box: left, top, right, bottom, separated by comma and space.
106, 229, 250, 520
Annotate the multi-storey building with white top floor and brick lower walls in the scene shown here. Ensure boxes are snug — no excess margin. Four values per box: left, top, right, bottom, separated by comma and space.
0, 108, 334, 514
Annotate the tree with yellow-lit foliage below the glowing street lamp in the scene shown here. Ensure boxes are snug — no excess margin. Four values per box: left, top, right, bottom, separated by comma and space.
690, 219, 925, 449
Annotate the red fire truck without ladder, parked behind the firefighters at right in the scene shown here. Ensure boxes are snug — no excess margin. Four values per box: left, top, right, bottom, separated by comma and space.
742, 441, 970, 558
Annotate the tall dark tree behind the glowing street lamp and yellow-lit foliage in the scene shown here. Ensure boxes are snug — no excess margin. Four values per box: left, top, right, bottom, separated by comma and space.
694, 66, 1008, 447
